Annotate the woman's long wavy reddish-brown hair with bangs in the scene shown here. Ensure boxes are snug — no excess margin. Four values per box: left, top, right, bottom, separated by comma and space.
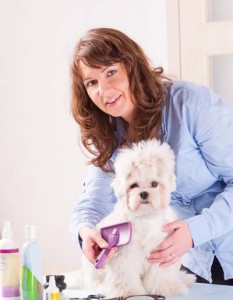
71, 28, 169, 171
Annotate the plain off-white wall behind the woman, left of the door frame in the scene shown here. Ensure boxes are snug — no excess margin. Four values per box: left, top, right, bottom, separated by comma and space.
0, 0, 167, 274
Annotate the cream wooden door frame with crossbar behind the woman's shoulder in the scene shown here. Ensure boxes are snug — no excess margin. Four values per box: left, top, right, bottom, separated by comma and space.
166, 0, 233, 87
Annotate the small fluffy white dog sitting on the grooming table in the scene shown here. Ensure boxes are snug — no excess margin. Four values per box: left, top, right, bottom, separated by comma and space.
70, 139, 195, 297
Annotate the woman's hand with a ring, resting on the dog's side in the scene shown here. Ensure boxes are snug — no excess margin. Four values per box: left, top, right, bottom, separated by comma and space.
148, 220, 193, 267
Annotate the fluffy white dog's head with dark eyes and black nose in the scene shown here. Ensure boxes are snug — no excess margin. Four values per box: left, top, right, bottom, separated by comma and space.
113, 140, 175, 215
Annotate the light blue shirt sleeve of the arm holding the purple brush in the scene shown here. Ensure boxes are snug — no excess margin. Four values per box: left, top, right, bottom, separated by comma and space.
69, 165, 116, 242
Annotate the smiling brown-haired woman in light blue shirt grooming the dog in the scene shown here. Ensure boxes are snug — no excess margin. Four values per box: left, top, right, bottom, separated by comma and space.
70, 28, 233, 285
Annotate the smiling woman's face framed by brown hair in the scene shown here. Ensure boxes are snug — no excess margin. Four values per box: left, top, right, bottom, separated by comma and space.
79, 61, 135, 123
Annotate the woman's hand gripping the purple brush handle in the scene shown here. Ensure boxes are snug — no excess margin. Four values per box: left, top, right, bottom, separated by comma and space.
79, 227, 117, 269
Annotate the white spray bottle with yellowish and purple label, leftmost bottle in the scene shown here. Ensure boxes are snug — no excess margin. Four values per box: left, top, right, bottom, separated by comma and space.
0, 221, 20, 299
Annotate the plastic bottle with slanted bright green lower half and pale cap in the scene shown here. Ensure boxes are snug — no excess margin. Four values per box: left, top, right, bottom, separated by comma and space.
21, 225, 43, 300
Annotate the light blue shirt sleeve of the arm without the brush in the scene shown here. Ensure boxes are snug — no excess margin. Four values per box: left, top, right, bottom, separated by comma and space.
186, 89, 233, 246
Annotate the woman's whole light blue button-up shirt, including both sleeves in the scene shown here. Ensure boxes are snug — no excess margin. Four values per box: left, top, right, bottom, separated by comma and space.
70, 81, 233, 282
